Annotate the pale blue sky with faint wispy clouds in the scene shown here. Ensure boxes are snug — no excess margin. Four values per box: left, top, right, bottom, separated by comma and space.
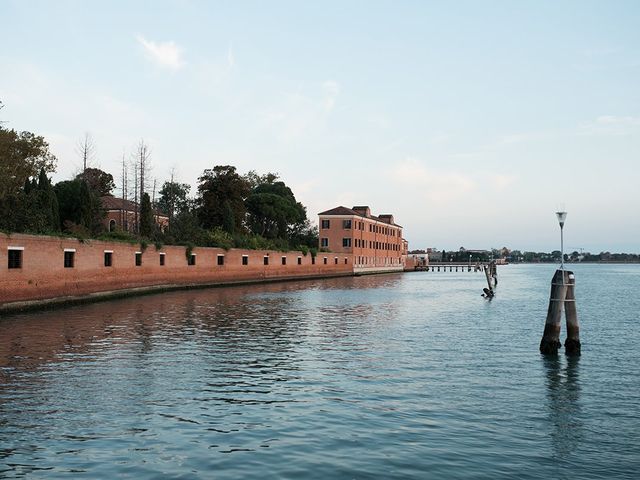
0, 0, 640, 253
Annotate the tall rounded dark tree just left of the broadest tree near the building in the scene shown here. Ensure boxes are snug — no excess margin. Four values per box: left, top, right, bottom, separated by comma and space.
198, 165, 250, 233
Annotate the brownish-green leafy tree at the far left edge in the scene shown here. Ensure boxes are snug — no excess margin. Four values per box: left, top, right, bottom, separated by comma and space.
0, 127, 56, 199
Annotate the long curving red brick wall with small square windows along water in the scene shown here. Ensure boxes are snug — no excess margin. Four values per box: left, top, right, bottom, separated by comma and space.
0, 233, 353, 305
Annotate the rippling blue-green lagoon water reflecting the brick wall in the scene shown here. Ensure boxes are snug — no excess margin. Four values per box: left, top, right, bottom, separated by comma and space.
0, 265, 640, 479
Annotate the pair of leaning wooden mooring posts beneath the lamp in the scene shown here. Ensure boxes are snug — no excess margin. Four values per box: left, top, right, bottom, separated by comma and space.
540, 269, 580, 355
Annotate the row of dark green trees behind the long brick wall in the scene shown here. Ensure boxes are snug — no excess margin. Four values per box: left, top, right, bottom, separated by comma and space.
0, 102, 318, 253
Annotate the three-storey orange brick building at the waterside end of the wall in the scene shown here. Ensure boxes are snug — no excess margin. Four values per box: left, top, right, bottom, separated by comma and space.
318, 206, 408, 273
